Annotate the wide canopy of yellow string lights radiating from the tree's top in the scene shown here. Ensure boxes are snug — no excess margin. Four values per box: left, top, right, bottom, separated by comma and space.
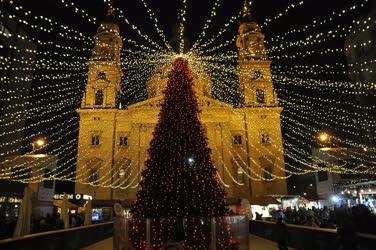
0, 0, 376, 189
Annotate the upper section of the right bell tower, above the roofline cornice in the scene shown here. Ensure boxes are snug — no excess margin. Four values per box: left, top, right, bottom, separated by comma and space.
236, 0, 278, 107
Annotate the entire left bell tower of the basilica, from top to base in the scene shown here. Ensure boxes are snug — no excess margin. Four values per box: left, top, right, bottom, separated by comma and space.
75, 11, 122, 201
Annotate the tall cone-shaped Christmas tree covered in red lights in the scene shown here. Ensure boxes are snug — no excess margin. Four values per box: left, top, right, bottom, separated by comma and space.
131, 58, 234, 249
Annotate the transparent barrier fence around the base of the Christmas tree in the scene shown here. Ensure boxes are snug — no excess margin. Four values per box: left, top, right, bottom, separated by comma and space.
122, 216, 249, 250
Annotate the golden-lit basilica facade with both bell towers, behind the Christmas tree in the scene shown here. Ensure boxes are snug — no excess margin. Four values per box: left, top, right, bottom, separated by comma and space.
75, 2, 287, 202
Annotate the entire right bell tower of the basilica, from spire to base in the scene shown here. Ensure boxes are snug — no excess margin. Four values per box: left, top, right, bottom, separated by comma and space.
236, 0, 287, 201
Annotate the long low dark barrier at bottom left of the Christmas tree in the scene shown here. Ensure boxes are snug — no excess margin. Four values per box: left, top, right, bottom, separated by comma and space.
0, 222, 113, 250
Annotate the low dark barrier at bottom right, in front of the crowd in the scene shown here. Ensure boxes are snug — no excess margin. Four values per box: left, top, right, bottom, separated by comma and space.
249, 220, 376, 250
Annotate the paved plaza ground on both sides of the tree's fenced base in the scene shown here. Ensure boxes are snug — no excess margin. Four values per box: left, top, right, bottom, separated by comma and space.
81, 235, 292, 250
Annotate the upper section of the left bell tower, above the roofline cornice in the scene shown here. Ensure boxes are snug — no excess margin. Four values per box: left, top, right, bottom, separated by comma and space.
81, 15, 122, 109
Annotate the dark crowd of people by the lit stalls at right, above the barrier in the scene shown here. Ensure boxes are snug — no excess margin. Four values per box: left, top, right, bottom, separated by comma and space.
262, 205, 376, 234
